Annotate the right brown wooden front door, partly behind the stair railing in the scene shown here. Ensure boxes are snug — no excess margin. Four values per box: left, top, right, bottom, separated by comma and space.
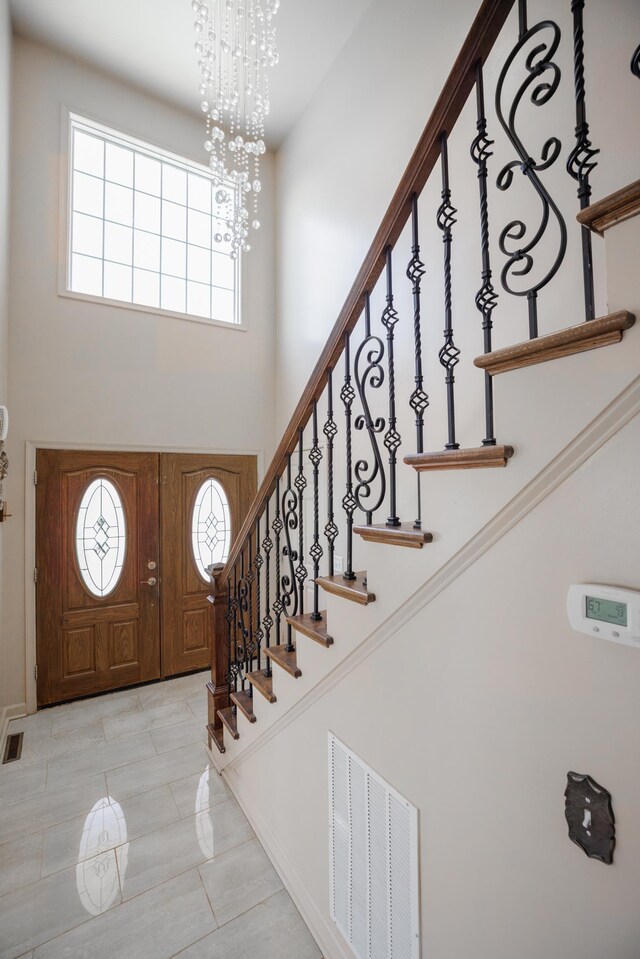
160, 453, 256, 676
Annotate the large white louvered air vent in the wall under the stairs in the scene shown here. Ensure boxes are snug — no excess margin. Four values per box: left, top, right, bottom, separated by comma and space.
329, 733, 420, 959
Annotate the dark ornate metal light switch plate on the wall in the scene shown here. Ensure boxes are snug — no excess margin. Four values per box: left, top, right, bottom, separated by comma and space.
564, 772, 616, 865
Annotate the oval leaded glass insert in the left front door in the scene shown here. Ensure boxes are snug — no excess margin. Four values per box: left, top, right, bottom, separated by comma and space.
76, 477, 127, 596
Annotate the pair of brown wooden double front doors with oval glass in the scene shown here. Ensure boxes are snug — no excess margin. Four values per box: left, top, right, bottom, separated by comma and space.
36, 450, 257, 706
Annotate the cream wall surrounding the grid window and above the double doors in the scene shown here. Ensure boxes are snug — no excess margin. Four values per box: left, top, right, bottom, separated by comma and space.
3, 39, 274, 703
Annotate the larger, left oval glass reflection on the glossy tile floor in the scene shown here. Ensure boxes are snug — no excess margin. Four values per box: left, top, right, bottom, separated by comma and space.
76, 796, 129, 916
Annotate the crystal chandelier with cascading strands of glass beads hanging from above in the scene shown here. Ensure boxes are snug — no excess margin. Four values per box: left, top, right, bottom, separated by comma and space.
191, 0, 280, 259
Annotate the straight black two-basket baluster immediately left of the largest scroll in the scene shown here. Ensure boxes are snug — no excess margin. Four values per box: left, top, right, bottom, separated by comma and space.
471, 60, 498, 446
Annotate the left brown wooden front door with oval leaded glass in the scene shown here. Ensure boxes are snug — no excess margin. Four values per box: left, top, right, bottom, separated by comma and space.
36, 450, 161, 705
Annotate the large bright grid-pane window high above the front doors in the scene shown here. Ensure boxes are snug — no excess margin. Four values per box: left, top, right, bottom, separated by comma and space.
67, 115, 240, 324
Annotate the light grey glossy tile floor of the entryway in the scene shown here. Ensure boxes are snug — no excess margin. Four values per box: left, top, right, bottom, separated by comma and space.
0, 673, 320, 959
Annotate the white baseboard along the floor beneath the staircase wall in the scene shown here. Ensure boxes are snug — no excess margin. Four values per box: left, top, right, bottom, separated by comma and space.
222, 767, 353, 959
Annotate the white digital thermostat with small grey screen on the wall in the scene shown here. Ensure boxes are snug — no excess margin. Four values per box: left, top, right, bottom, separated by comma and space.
567, 583, 640, 648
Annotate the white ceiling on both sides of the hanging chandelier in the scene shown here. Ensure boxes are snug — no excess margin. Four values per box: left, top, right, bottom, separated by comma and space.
10, 0, 373, 146
